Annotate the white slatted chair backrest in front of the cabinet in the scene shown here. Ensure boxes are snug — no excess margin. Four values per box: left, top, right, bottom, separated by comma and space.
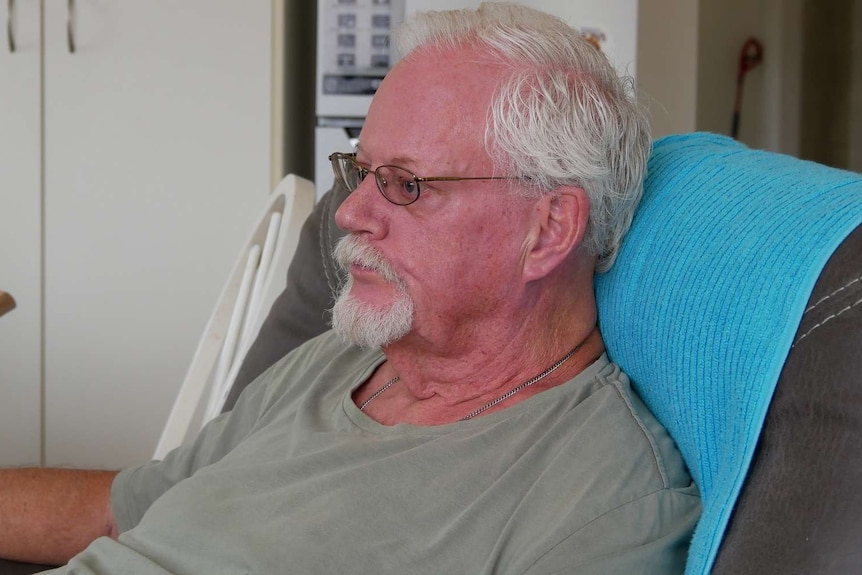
153, 175, 315, 459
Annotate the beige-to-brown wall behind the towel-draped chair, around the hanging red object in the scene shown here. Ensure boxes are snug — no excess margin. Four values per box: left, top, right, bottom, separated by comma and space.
637, 0, 862, 171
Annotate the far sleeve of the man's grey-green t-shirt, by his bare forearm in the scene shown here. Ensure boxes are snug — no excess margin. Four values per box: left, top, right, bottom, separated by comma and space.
111, 366, 286, 533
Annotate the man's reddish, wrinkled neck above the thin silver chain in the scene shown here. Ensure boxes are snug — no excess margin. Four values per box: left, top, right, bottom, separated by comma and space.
354, 258, 604, 425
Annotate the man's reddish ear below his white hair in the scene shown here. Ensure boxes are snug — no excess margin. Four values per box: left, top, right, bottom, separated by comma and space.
524, 186, 590, 281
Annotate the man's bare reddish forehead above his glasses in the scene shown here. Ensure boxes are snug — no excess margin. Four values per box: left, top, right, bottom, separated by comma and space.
360, 48, 502, 169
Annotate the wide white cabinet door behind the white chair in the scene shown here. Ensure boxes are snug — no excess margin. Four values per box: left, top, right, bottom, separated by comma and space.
44, 0, 271, 467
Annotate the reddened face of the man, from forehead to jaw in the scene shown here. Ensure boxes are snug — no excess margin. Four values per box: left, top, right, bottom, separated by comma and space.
334, 46, 531, 347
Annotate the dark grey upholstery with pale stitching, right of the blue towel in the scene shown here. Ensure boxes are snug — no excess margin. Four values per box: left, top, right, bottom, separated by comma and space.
713, 227, 862, 574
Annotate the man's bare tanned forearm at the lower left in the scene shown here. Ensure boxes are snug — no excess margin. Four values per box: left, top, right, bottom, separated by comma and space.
0, 468, 117, 565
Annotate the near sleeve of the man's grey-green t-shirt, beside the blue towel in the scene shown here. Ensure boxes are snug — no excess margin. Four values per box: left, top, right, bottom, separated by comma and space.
526, 485, 700, 575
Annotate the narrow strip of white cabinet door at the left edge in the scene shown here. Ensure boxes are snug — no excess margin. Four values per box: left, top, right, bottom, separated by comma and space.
0, 0, 42, 466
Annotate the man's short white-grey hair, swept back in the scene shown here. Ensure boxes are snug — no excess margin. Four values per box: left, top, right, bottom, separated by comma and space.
394, 2, 651, 272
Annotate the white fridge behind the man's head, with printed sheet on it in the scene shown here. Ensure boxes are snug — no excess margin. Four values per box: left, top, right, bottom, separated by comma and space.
314, 0, 638, 198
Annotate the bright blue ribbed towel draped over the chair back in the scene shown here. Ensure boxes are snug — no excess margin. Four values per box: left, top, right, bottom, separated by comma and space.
596, 133, 862, 574
